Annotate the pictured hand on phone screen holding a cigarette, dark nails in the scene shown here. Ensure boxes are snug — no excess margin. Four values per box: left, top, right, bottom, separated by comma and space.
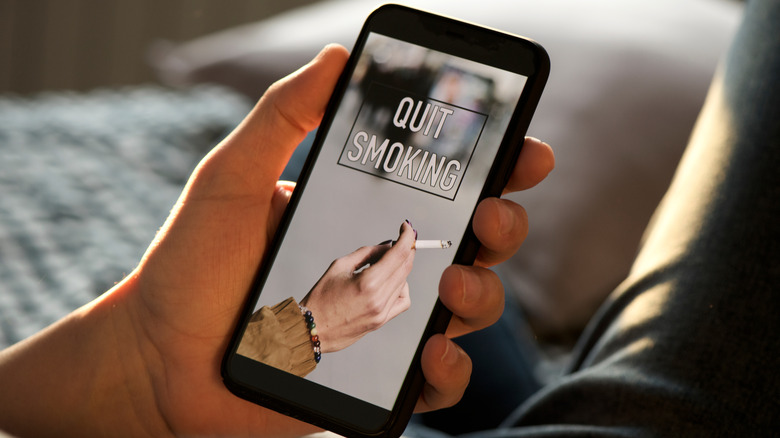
301, 222, 415, 353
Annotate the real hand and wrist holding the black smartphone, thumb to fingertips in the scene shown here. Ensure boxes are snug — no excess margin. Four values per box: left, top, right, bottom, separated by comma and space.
0, 42, 553, 436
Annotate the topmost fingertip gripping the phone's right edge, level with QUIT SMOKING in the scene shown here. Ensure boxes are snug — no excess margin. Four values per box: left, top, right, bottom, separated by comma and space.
504, 137, 555, 194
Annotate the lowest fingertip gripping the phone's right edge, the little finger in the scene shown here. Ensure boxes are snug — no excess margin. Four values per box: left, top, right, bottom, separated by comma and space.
415, 335, 471, 412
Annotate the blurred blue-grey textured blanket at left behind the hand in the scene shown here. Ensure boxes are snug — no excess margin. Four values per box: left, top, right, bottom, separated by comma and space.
0, 85, 251, 348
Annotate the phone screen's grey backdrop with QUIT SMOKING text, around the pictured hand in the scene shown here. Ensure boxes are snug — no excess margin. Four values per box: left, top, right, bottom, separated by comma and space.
238, 32, 527, 410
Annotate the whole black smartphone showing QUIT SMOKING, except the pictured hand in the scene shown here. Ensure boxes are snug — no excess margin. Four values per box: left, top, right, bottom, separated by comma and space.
222, 5, 549, 437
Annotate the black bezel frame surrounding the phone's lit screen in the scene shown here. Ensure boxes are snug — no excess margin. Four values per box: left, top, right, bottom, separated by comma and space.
222, 5, 549, 436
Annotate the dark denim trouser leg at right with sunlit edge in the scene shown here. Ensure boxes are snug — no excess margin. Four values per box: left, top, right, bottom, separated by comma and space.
407, 0, 780, 438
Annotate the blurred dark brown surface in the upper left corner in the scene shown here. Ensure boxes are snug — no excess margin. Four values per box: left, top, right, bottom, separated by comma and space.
0, 0, 316, 94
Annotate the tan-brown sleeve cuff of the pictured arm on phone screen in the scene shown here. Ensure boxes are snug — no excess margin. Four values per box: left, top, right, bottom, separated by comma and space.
238, 298, 317, 377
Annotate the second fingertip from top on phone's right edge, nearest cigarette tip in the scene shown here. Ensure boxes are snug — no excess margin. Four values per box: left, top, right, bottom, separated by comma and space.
472, 198, 528, 267
